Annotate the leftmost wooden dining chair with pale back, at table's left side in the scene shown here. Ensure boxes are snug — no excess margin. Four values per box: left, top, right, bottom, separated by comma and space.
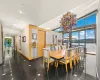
43, 48, 54, 70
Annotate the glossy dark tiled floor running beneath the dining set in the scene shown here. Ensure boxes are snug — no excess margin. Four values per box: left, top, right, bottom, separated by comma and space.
0, 51, 94, 80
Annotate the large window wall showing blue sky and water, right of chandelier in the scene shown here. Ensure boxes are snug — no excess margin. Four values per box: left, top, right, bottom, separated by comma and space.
63, 13, 96, 53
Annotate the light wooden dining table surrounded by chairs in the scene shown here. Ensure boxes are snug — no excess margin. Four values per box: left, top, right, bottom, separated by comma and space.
50, 51, 64, 68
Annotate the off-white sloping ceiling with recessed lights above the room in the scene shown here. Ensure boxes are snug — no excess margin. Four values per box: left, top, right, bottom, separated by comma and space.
0, 0, 95, 35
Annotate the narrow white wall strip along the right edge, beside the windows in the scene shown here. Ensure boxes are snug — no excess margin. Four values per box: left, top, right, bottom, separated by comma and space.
96, 2, 100, 80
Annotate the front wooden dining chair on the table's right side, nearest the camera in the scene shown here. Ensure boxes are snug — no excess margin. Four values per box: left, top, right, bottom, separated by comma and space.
60, 49, 72, 72
